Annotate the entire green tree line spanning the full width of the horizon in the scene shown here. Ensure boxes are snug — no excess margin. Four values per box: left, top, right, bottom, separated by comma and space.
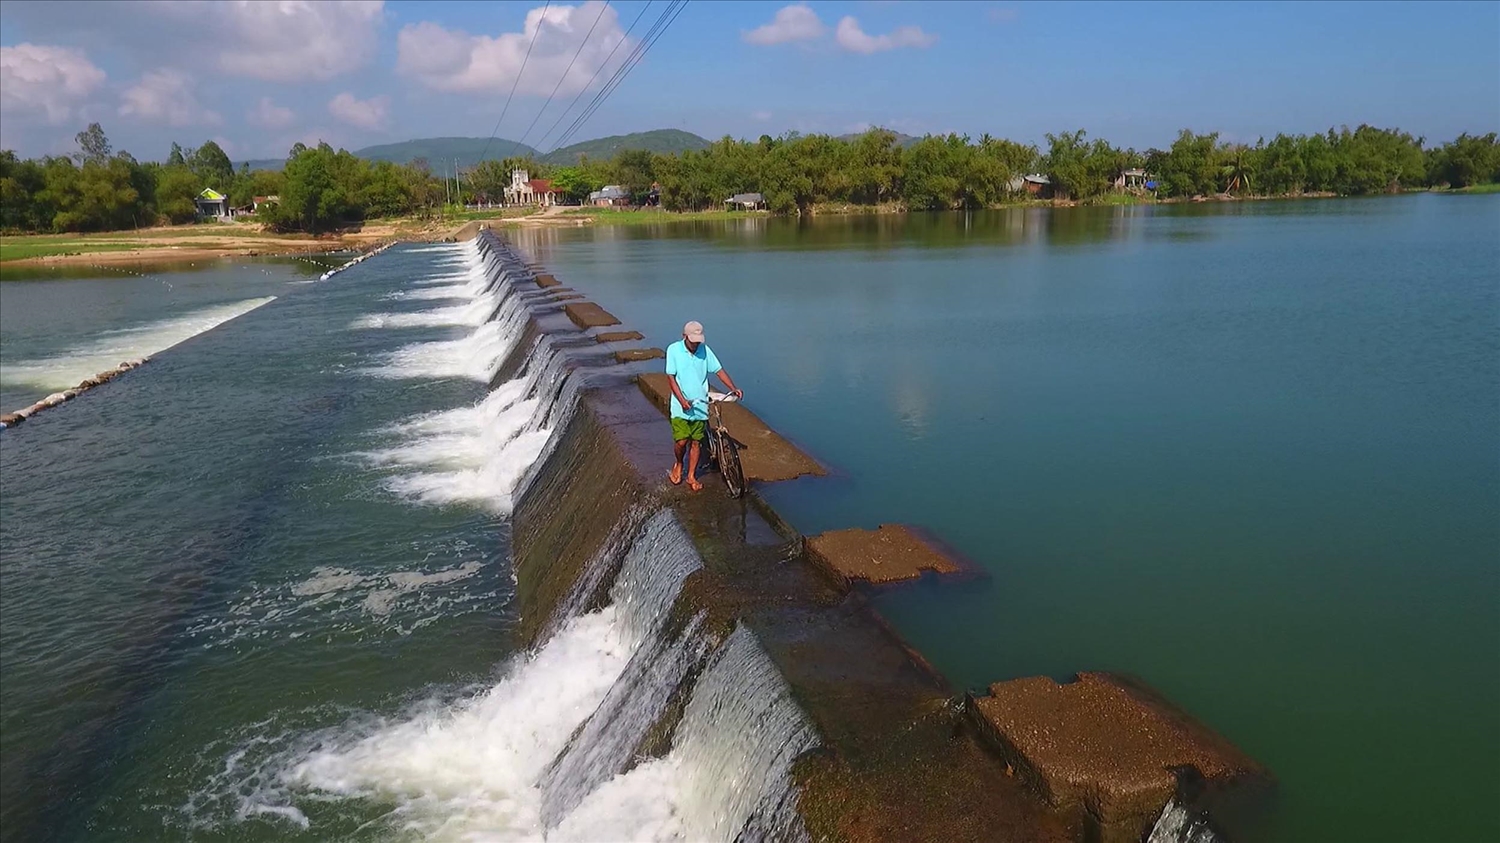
0, 123, 1500, 233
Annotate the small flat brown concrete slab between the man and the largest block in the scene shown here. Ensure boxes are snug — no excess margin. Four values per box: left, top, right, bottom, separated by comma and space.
807, 524, 963, 587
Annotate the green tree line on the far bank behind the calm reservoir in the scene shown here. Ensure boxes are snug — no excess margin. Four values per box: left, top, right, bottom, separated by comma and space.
467, 126, 1500, 213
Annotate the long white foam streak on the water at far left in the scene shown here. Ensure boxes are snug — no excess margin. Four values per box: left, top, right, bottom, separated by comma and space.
0, 296, 276, 390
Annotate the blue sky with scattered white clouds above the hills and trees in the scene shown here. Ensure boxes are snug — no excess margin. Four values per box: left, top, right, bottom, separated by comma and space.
0, 0, 1500, 159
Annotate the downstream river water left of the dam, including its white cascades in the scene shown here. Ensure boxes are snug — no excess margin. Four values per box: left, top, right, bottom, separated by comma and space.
0, 240, 813, 843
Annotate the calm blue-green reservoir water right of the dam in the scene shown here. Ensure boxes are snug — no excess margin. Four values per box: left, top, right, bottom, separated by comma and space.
515, 195, 1500, 842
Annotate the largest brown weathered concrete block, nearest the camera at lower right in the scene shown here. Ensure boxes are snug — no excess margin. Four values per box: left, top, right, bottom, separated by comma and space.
968, 674, 1269, 842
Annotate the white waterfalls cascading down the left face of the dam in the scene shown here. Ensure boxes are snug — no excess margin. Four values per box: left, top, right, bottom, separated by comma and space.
264, 234, 816, 843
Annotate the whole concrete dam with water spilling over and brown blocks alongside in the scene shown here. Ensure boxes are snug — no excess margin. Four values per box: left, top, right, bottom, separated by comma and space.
441, 227, 1274, 843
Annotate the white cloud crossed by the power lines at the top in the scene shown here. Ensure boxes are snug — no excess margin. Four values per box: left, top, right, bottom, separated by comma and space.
396, 0, 630, 96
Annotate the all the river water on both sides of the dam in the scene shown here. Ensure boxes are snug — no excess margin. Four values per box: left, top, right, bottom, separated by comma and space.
0, 195, 1500, 843
